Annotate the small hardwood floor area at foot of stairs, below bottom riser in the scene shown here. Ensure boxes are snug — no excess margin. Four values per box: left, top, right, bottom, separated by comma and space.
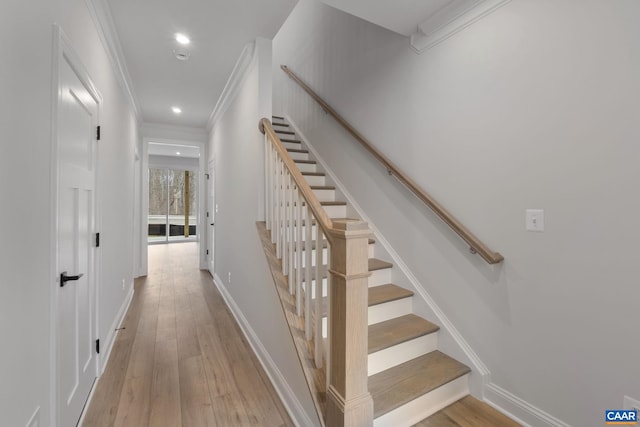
413, 396, 520, 427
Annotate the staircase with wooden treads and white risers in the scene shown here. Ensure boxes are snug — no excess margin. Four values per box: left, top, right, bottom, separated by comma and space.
260, 116, 517, 427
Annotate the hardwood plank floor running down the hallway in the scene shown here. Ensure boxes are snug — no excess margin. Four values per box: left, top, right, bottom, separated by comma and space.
82, 243, 293, 427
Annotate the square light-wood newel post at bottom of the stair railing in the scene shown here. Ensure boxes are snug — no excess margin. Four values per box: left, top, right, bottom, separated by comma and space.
326, 220, 373, 427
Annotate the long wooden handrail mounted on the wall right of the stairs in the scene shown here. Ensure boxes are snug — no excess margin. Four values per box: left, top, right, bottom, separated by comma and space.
280, 65, 504, 264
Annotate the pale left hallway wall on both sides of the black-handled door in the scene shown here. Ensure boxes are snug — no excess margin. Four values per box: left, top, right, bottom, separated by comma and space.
0, 0, 139, 426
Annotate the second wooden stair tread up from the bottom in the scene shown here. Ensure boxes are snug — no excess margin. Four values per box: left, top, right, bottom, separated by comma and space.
369, 314, 440, 354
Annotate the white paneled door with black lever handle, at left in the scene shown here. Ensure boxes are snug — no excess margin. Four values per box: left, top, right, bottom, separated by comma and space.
56, 45, 98, 427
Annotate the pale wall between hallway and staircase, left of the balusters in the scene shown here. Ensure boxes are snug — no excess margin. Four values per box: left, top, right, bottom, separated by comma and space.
209, 39, 318, 425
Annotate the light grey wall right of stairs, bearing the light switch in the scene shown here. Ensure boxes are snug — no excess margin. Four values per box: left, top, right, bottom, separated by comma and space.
273, 0, 640, 426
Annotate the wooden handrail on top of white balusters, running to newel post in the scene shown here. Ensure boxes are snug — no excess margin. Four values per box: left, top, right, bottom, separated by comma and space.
258, 118, 333, 242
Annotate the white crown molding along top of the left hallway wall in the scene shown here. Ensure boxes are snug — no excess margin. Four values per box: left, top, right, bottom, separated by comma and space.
85, 0, 142, 123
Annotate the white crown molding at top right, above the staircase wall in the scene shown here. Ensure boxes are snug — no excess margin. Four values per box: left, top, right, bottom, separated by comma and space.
411, 0, 511, 53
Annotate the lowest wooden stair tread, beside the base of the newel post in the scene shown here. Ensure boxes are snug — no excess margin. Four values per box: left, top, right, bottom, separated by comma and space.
369, 350, 470, 418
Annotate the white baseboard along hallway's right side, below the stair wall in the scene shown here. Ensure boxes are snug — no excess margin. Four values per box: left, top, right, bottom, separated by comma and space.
213, 274, 315, 427
